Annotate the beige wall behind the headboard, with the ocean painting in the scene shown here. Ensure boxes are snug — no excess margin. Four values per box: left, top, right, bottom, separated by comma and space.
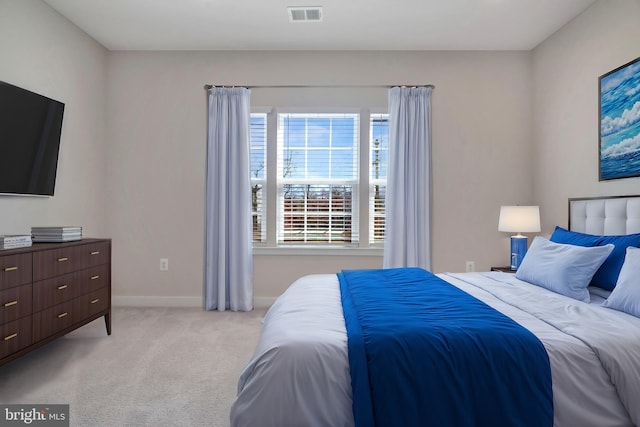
532, 0, 640, 233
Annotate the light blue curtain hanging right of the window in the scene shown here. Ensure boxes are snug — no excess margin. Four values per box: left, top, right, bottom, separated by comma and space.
383, 87, 433, 270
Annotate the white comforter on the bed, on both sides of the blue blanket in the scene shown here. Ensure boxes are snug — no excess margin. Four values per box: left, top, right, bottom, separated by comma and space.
231, 272, 640, 427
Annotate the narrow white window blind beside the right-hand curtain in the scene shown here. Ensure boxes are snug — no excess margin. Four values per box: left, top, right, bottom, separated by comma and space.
369, 114, 389, 246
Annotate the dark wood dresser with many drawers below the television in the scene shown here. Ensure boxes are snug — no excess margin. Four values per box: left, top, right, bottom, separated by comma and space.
0, 239, 111, 365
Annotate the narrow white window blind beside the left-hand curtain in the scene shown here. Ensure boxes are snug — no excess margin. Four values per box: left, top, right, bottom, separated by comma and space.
250, 113, 267, 244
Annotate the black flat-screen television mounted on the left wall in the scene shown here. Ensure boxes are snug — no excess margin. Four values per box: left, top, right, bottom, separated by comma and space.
0, 81, 64, 196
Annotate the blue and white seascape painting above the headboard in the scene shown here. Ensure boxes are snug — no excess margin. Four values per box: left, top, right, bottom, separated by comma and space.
600, 58, 640, 180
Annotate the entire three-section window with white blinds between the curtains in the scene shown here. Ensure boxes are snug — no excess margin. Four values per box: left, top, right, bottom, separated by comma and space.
251, 110, 389, 248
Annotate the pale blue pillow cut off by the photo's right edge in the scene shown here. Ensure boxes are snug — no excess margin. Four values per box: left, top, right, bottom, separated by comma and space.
602, 246, 640, 317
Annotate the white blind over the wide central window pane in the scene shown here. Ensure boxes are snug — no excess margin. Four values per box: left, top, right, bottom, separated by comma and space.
277, 113, 360, 246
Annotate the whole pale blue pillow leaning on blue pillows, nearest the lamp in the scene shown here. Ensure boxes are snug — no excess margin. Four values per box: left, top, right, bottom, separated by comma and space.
516, 236, 614, 302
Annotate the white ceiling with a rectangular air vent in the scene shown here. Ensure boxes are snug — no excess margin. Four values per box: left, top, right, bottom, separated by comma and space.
44, 0, 595, 50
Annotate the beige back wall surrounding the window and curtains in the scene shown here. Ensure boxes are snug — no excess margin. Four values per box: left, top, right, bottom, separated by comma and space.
107, 52, 533, 300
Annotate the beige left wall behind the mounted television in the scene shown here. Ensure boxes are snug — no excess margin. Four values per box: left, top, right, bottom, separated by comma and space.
0, 0, 109, 237
